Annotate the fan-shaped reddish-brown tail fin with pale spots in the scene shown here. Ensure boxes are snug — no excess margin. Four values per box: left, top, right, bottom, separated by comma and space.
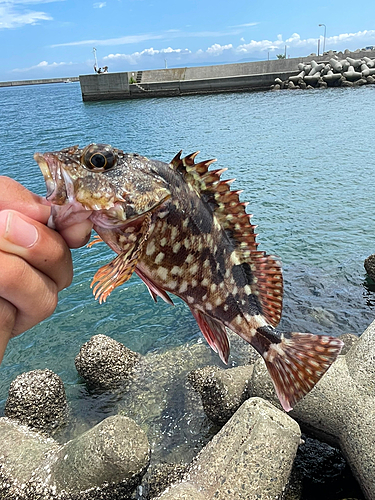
263, 333, 343, 411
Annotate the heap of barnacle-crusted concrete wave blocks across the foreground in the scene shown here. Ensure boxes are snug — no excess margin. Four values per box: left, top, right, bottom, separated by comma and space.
0, 322, 375, 500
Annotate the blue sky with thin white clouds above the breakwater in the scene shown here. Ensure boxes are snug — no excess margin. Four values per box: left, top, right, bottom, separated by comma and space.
0, 0, 375, 81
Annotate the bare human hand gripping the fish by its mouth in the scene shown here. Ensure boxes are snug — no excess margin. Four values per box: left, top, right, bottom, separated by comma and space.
0, 176, 92, 362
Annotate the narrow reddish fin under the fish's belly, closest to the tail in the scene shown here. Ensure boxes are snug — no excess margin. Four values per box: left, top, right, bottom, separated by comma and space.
190, 308, 230, 364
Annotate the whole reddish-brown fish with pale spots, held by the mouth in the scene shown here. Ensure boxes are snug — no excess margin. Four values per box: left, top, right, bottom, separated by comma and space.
34, 143, 343, 411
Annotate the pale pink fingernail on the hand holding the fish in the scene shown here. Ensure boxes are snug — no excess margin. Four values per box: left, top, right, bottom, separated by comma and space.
0, 210, 38, 248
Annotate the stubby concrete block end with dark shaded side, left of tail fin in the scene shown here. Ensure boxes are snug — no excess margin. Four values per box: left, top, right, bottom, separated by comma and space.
188, 365, 253, 426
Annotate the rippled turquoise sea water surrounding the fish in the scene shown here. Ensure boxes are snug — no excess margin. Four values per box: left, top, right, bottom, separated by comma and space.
0, 84, 375, 434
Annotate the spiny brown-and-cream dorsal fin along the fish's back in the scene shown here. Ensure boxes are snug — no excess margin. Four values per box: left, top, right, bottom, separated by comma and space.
170, 151, 283, 327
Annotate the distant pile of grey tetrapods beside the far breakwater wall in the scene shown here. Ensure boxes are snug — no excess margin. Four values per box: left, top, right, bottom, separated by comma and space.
271, 54, 375, 90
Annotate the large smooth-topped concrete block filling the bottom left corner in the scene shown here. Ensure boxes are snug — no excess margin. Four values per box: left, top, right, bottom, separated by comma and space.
0, 416, 150, 500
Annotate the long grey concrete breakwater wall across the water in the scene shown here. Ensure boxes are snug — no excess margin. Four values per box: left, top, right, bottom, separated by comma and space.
79, 50, 375, 101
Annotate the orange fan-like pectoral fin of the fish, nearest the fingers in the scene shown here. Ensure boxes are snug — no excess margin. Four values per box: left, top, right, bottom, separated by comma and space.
90, 214, 151, 304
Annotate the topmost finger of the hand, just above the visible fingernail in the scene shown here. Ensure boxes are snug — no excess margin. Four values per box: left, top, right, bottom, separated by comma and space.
0, 175, 51, 224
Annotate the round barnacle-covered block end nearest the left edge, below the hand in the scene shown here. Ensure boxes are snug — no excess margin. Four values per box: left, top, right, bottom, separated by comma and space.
4, 369, 67, 433
